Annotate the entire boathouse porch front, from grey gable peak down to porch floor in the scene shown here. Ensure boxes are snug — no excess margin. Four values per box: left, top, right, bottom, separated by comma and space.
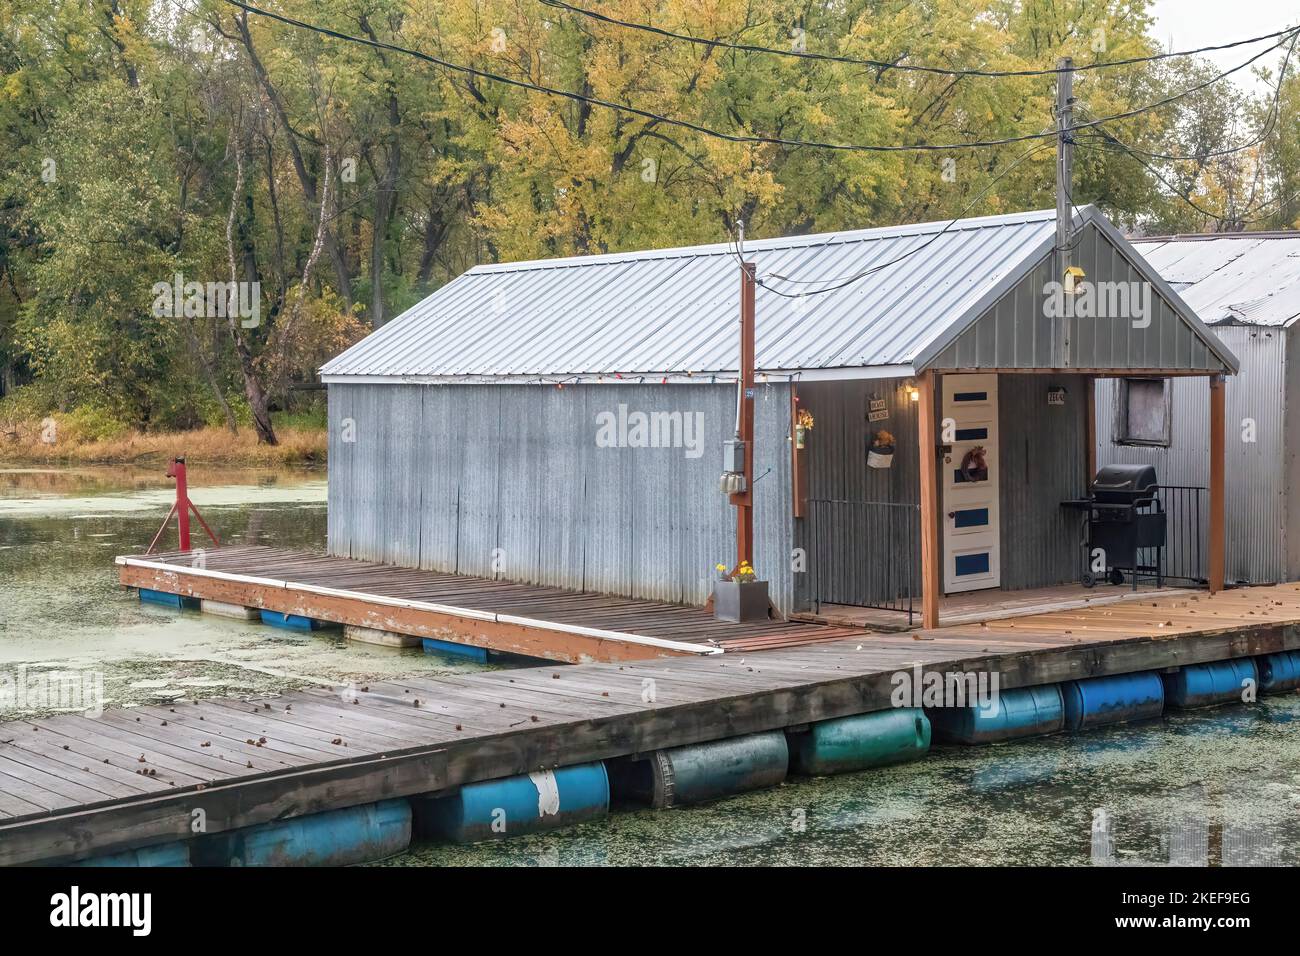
792, 209, 1236, 628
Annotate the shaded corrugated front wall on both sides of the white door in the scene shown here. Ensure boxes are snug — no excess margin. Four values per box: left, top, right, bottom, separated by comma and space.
796, 375, 1087, 607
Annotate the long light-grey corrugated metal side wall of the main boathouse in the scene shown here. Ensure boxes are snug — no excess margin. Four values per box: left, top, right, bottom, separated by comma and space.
329, 384, 792, 609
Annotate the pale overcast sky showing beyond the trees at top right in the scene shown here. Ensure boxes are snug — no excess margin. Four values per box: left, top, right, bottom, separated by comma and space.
1151, 0, 1300, 88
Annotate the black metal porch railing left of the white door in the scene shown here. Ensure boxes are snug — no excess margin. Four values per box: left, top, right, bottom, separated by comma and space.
803, 498, 920, 626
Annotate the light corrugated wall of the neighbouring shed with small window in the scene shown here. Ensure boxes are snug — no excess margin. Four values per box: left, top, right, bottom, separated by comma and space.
1097, 325, 1300, 584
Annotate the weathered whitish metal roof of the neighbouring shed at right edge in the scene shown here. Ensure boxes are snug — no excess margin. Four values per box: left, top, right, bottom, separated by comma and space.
1131, 233, 1300, 326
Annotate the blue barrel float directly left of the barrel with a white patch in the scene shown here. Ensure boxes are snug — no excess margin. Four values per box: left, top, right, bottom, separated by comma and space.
194, 800, 411, 866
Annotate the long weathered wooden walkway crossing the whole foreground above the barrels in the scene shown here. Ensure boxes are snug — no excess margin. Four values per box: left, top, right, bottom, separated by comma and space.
0, 584, 1300, 865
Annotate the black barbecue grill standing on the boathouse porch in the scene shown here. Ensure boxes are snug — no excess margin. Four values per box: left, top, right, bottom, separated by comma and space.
1061, 464, 1167, 589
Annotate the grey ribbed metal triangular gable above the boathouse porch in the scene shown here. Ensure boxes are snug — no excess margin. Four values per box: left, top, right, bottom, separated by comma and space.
927, 225, 1231, 371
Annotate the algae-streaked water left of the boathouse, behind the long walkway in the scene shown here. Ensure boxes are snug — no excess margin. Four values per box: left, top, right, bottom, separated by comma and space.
0, 464, 496, 721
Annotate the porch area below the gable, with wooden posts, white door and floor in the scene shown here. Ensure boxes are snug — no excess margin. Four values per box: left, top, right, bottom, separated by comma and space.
793, 371, 1223, 630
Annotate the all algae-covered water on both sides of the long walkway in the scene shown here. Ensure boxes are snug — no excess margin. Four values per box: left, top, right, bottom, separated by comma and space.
0, 466, 1300, 866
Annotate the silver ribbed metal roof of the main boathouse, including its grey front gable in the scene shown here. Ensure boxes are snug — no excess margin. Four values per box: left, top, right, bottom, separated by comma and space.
321, 206, 1236, 382
